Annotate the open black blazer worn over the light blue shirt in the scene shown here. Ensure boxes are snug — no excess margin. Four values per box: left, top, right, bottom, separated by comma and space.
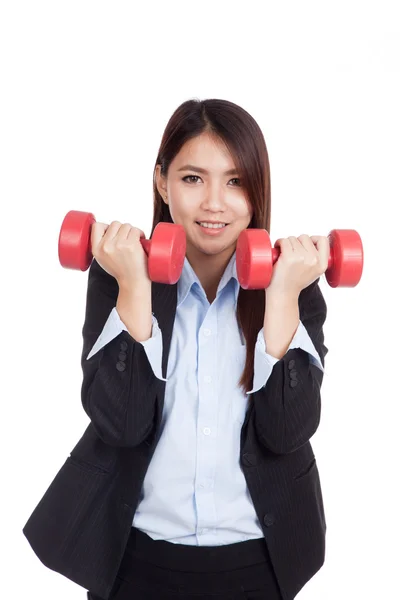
23, 260, 328, 600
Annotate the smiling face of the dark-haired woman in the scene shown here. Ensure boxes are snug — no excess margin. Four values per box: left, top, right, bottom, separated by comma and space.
156, 133, 253, 256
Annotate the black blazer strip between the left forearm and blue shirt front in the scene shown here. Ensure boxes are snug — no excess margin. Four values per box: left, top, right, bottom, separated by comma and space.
151, 282, 178, 378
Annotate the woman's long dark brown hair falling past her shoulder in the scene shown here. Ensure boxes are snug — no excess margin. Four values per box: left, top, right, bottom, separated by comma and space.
151, 99, 271, 392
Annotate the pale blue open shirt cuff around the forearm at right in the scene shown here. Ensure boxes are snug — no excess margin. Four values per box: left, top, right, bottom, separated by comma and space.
246, 321, 324, 394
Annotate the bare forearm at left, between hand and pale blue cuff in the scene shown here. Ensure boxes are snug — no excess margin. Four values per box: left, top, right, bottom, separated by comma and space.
116, 282, 152, 342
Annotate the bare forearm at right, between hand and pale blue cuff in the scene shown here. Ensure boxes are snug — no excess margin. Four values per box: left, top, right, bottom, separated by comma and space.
264, 288, 300, 359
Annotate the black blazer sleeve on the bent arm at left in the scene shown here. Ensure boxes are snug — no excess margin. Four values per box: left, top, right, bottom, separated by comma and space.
81, 259, 164, 447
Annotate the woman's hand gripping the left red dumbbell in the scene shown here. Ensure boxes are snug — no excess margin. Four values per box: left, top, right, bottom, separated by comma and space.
91, 221, 151, 286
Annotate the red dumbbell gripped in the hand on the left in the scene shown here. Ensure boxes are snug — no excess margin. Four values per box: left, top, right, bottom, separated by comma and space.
58, 210, 186, 284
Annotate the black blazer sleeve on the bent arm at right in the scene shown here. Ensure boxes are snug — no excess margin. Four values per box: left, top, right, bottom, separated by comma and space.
251, 278, 328, 454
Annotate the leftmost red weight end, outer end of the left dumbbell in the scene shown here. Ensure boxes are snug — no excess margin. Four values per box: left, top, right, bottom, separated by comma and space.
58, 210, 96, 271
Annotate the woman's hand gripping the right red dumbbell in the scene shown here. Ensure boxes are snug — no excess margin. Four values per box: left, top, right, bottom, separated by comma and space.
266, 234, 330, 295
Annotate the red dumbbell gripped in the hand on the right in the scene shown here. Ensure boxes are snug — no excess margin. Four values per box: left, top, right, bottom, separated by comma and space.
236, 229, 364, 290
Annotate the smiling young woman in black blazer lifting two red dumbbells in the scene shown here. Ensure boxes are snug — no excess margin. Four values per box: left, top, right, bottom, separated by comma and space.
24, 99, 329, 600
